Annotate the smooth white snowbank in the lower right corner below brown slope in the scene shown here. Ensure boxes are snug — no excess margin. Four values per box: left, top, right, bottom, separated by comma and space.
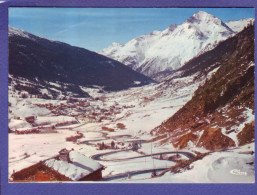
120, 143, 255, 183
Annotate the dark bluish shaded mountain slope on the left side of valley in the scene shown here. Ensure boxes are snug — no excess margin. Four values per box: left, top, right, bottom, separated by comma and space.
9, 27, 153, 90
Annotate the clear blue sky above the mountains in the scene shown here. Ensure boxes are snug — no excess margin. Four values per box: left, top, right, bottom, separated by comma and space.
9, 8, 254, 51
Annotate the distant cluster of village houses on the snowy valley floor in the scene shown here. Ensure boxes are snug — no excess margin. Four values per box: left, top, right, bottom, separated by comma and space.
9, 92, 137, 134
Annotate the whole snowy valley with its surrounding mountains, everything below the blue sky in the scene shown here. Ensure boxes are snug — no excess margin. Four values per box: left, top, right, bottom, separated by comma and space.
8, 11, 255, 183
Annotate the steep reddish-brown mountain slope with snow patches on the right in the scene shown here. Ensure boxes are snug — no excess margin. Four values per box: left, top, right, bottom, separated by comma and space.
153, 25, 255, 150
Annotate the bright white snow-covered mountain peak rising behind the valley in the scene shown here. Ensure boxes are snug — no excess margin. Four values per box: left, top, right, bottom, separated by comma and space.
98, 11, 252, 78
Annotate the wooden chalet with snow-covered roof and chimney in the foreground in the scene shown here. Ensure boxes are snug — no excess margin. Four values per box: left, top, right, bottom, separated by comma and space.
11, 149, 104, 182
